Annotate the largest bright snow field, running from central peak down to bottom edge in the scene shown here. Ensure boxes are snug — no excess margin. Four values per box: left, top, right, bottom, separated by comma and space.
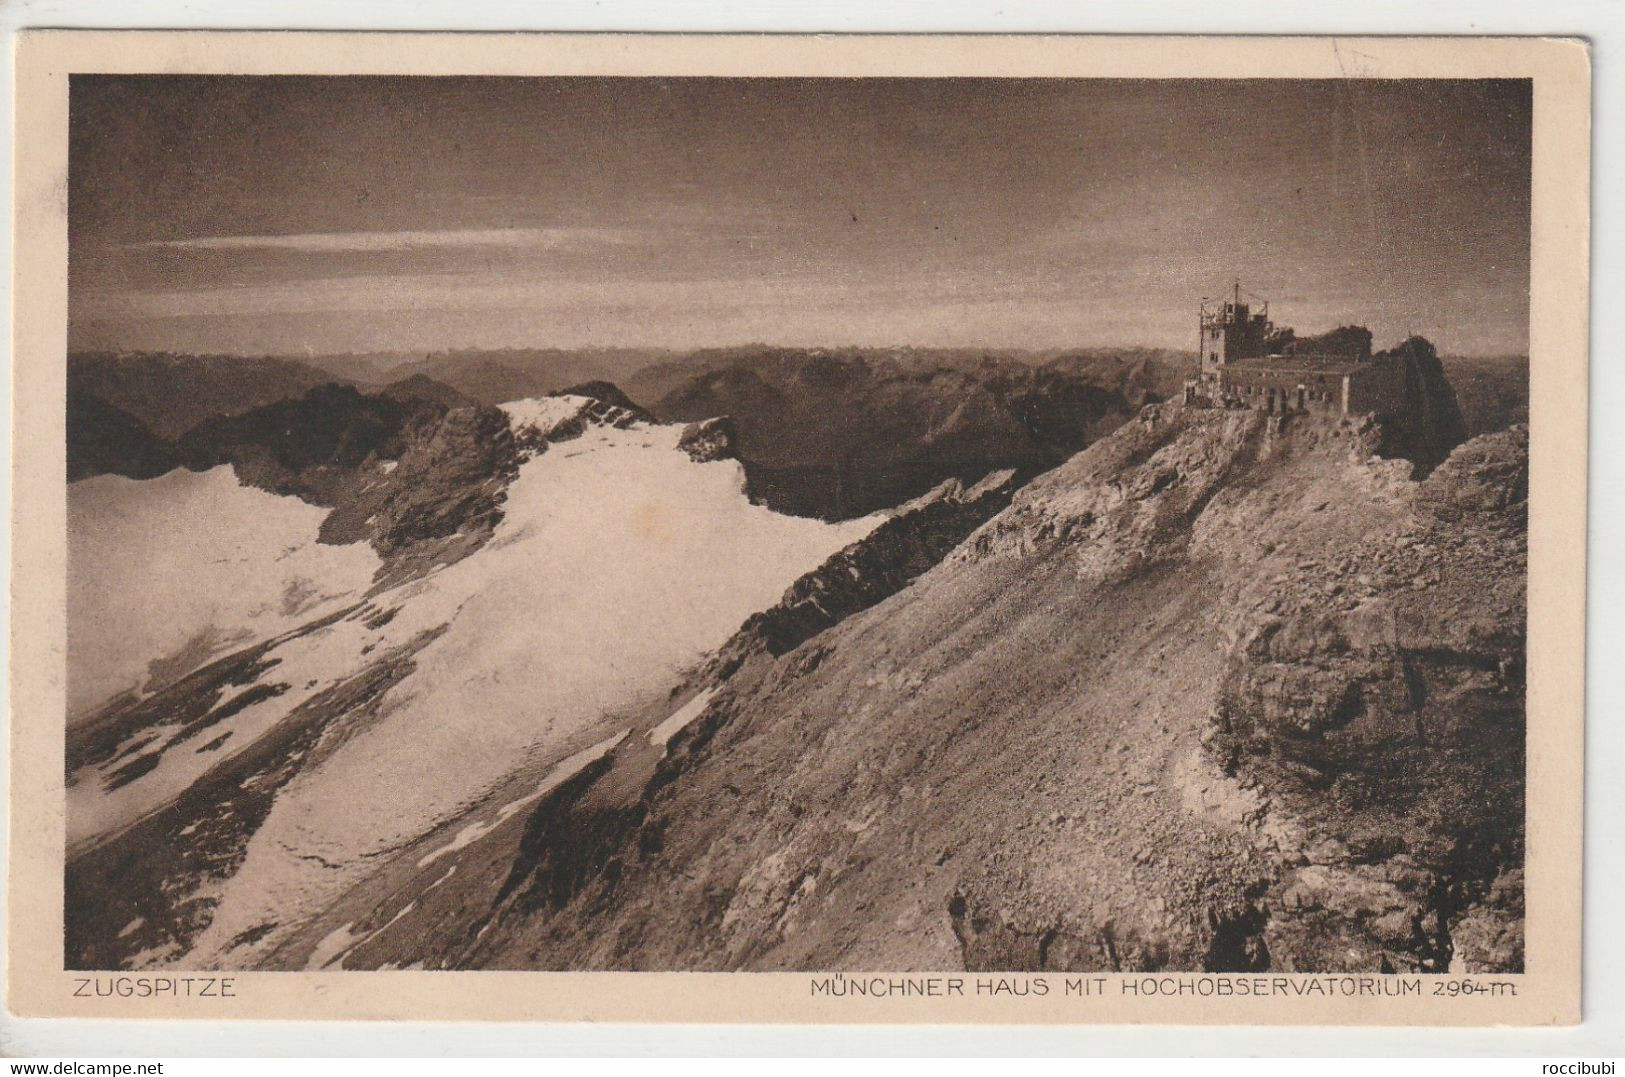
187, 409, 879, 967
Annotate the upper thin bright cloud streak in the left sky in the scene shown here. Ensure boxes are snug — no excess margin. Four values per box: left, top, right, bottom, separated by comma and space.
127, 227, 639, 253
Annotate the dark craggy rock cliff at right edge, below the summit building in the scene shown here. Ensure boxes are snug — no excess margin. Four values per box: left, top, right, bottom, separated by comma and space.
1209, 427, 1528, 971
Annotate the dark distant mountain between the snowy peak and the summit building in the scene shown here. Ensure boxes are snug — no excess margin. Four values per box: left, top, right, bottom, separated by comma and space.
634, 348, 1144, 520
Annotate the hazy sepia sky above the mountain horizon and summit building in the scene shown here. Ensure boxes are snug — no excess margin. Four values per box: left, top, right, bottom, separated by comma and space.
68, 76, 1531, 362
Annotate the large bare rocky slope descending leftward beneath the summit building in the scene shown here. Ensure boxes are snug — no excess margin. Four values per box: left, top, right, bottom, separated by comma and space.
393, 396, 1526, 971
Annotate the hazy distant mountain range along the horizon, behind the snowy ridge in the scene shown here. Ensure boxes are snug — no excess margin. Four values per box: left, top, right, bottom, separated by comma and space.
68, 344, 1528, 518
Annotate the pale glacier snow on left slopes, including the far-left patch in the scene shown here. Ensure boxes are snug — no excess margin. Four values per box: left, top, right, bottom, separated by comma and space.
70, 398, 881, 968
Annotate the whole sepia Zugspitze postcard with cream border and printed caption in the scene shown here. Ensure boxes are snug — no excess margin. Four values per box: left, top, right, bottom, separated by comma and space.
7, 31, 1591, 1025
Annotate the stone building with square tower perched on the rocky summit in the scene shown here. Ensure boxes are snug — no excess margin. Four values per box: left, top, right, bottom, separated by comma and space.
1185, 283, 1407, 416
